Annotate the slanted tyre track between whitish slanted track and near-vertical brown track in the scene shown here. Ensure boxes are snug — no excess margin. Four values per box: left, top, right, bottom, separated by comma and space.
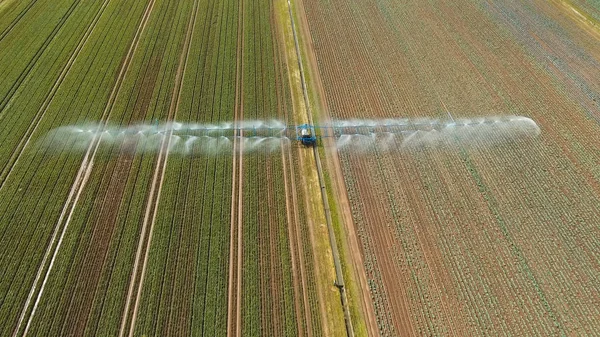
119, 0, 199, 336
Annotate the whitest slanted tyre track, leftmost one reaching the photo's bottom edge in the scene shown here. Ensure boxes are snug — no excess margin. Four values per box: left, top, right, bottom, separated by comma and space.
13, 0, 155, 336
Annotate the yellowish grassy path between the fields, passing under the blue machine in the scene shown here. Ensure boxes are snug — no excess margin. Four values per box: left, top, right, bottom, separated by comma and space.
276, 1, 360, 335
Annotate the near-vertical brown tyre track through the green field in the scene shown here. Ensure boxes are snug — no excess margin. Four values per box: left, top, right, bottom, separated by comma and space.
227, 0, 244, 336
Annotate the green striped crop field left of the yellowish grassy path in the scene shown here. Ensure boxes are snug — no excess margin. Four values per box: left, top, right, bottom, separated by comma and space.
0, 0, 344, 336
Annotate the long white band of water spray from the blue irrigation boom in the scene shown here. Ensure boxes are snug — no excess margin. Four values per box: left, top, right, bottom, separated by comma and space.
39, 116, 540, 155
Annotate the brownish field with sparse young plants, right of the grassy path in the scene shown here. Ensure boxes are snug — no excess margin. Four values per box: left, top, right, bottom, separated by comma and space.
302, 0, 600, 336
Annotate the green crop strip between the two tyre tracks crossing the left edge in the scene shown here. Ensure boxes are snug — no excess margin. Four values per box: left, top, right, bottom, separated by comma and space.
0, 1, 116, 185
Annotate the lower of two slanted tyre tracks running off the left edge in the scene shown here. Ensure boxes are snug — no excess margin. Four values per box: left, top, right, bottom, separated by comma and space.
0, 0, 110, 191
